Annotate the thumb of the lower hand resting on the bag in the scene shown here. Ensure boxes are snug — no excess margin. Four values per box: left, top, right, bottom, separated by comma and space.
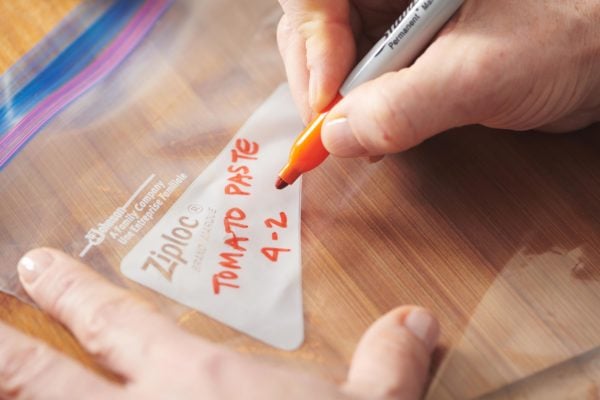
344, 306, 439, 400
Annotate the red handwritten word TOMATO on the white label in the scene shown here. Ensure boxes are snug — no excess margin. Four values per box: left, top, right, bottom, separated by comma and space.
212, 207, 249, 294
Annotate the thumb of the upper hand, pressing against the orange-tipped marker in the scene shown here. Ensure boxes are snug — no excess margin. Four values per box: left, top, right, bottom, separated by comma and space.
322, 47, 472, 157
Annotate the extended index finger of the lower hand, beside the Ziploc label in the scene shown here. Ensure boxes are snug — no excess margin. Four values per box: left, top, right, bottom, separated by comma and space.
18, 248, 216, 379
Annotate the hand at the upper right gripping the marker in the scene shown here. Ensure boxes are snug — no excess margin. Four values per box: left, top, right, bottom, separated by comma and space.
278, 0, 600, 157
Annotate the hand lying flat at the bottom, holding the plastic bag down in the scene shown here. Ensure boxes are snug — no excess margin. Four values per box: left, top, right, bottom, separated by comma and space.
0, 249, 439, 400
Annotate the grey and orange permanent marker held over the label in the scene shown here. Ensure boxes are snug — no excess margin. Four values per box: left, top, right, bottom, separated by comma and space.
275, 0, 464, 189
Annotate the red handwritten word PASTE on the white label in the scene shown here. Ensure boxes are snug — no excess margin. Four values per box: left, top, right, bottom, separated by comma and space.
225, 139, 260, 196
